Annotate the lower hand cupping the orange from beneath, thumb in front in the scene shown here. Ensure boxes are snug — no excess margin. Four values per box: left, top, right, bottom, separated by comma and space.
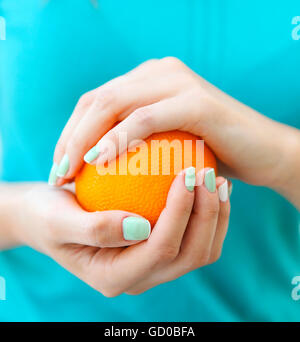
14, 170, 230, 297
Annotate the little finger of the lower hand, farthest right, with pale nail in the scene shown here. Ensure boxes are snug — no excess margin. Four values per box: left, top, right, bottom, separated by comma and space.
209, 177, 230, 263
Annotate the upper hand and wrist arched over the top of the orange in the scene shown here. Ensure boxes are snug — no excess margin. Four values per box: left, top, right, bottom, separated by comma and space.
54, 57, 300, 196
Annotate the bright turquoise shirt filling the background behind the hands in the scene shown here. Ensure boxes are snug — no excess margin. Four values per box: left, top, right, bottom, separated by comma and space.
0, 0, 300, 321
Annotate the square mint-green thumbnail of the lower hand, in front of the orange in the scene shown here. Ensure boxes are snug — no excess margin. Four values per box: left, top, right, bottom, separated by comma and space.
123, 216, 151, 241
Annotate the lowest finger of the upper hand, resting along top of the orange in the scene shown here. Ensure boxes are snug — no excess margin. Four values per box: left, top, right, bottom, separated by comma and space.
89, 98, 186, 165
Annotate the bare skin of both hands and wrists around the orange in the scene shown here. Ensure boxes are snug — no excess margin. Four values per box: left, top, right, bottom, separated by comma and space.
0, 57, 300, 297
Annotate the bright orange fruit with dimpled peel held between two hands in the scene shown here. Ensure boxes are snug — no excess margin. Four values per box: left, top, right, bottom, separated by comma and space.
75, 131, 217, 227
